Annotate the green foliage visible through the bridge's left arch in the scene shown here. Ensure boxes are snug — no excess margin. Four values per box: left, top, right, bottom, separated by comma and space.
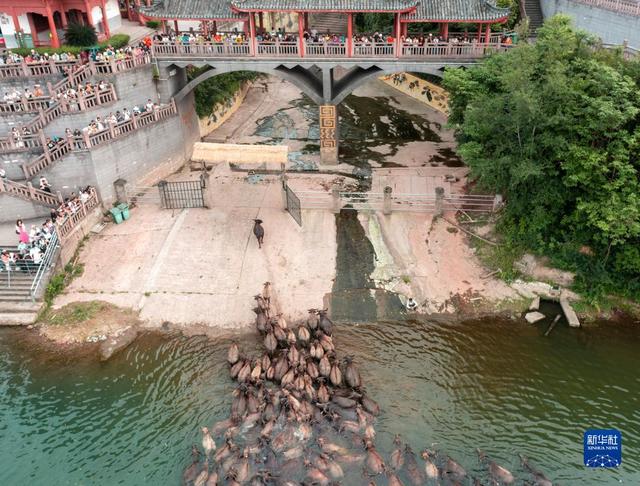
188, 66, 261, 118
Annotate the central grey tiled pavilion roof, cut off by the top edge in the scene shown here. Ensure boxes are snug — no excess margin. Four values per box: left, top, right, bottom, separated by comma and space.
231, 0, 418, 12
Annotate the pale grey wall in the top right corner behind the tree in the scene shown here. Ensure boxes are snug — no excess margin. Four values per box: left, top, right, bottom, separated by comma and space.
540, 0, 640, 48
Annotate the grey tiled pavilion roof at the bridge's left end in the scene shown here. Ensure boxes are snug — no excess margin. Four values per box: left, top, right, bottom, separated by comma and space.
140, 0, 246, 20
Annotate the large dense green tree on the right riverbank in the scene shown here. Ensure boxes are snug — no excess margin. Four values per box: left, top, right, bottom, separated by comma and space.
444, 16, 640, 298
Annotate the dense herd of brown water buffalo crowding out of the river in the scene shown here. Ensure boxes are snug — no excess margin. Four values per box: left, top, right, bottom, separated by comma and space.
183, 282, 552, 486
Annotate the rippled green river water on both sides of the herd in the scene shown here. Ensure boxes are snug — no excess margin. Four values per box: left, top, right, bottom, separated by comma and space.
0, 319, 640, 485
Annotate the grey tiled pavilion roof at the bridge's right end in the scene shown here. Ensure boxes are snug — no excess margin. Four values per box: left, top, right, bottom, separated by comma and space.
402, 0, 510, 22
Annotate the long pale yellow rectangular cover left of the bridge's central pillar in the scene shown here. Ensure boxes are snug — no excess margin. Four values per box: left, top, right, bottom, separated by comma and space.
191, 142, 289, 168
